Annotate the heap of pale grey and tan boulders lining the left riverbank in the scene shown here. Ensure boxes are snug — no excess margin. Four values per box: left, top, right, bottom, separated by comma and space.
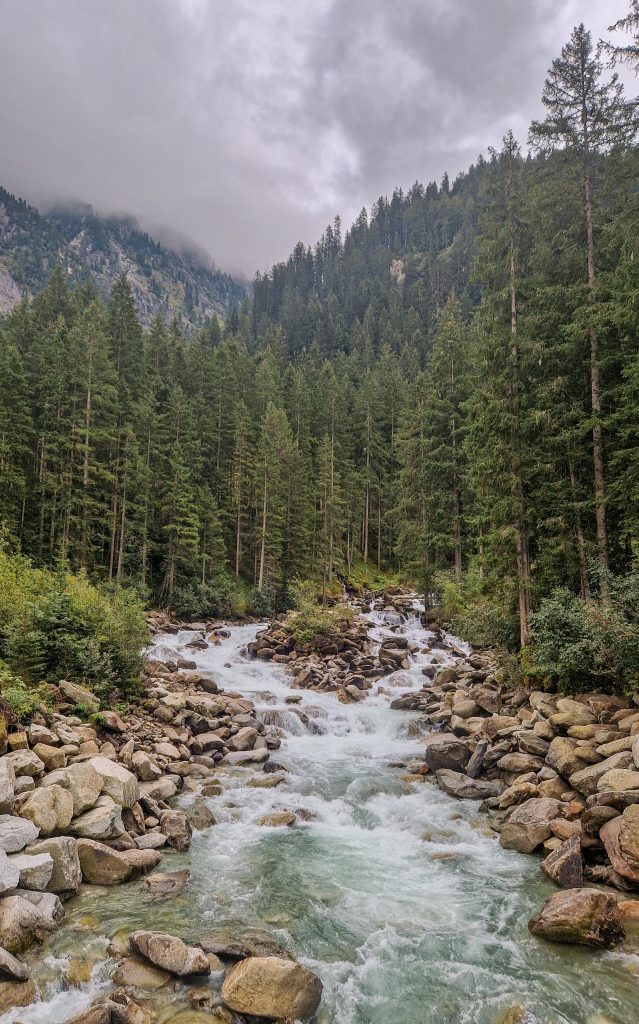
0, 624, 280, 1013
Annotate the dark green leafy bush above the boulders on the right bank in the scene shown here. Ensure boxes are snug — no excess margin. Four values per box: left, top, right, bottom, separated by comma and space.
524, 570, 639, 693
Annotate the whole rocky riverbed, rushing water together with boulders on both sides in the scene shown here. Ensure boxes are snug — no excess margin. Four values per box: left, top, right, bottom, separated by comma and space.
0, 595, 639, 1024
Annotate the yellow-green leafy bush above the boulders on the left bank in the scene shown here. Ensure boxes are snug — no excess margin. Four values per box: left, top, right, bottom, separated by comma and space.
0, 551, 148, 696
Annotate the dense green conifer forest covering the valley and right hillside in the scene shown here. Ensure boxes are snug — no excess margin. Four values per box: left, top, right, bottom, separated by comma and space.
0, 22, 639, 688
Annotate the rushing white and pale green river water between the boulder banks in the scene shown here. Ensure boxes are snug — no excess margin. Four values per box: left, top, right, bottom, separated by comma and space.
2, 612, 639, 1024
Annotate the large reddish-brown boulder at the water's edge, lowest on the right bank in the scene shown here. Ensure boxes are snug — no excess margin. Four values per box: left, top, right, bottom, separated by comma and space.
528, 889, 626, 949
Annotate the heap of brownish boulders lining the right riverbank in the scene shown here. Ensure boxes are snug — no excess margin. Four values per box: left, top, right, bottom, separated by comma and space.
392, 652, 639, 945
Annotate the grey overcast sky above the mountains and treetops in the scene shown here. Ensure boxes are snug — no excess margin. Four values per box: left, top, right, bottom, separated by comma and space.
0, 0, 628, 274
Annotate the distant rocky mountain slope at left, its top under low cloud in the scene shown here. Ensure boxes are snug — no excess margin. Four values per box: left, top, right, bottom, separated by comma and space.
0, 187, 247, 328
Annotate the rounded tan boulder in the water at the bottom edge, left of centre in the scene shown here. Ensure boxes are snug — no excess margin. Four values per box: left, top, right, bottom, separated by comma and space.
222, 956, 322, 1020
